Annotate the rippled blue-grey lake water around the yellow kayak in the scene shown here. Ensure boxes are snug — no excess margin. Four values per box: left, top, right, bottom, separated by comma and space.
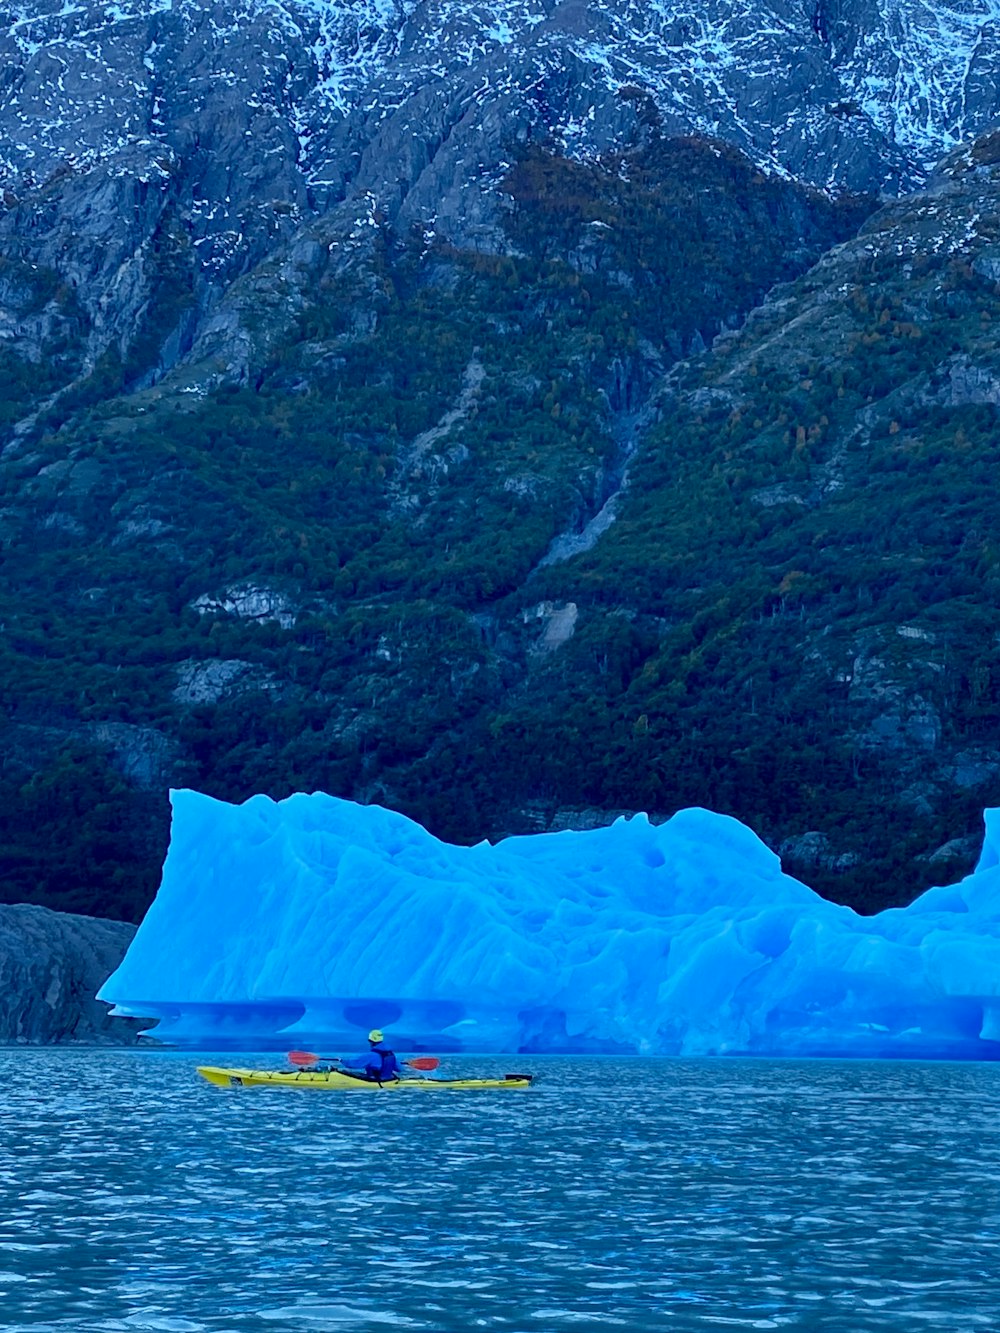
0, 1050, 1000, 1333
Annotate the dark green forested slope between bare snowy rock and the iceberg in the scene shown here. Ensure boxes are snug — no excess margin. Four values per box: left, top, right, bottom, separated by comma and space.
0, 137, 1000, 918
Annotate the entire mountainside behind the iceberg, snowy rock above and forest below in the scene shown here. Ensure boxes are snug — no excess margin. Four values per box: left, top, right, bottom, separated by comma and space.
0, 3, 1000, 918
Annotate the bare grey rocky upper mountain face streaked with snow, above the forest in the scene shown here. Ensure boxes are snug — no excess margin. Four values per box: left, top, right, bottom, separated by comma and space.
0, 0, 1000, 383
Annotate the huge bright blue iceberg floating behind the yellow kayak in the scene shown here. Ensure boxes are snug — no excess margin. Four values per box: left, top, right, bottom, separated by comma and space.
99, 790, 1000, 1060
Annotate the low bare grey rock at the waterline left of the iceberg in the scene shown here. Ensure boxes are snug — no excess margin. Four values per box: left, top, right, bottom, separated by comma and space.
0, 904, 141, 1046
